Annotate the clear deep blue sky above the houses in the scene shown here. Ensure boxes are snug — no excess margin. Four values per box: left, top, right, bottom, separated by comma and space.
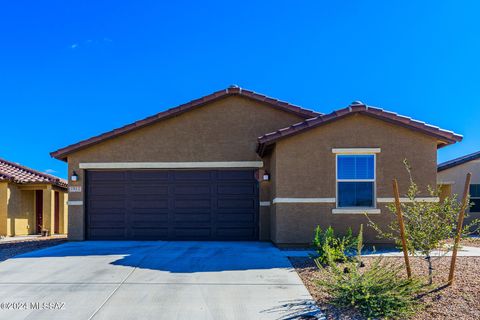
0, 0, 480, 177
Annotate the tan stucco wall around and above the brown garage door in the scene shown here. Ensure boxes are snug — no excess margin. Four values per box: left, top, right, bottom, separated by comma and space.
64, 97, 302, 240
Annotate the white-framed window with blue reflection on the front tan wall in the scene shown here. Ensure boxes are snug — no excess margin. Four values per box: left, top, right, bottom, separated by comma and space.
337, 154, 375, 208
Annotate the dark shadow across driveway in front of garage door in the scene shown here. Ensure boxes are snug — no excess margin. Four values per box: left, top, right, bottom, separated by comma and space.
10, 241, 292, 273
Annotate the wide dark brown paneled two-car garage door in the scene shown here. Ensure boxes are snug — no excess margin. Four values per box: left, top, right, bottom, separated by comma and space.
86, 170, 258, 240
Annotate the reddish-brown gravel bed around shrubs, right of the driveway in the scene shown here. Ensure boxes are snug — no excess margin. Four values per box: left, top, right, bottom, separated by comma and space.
290, 257, 480, 320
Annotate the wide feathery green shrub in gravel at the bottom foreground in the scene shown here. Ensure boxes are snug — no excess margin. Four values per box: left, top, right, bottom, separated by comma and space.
318, 258, 423, 319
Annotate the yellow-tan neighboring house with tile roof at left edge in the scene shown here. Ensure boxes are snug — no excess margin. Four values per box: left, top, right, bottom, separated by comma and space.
0, 159, 68, 236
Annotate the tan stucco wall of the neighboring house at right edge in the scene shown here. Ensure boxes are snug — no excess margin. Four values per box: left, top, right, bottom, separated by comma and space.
437, 160, 480, 222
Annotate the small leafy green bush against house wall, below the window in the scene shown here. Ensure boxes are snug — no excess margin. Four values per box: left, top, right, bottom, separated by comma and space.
313, 226, 357, 265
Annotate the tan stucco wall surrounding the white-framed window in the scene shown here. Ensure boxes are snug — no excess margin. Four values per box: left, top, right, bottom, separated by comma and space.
271, 115, 437, 244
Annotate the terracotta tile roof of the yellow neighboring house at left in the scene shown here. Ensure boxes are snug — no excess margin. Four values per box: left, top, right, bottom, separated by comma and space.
0, 158, 67, 189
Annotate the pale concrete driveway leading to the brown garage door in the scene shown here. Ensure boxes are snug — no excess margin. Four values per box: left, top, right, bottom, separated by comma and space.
0, 241, 320, 320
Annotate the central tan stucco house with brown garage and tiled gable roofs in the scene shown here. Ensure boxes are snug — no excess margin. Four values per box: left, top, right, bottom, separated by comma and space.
51, 87, 462, 244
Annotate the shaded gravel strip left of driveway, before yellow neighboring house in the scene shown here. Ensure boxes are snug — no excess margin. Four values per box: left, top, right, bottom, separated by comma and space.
0, 236, 67, 262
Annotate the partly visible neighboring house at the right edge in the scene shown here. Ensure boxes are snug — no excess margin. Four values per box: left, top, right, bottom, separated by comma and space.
437, 151, 480, 222
